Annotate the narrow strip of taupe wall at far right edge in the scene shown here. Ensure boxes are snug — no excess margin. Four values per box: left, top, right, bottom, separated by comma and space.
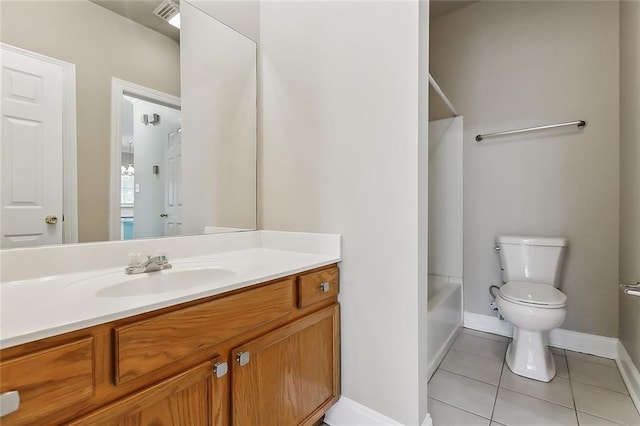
620, 1, 640, 366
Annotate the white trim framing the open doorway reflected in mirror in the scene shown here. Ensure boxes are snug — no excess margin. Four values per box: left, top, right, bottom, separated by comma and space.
109, 77, 181, 241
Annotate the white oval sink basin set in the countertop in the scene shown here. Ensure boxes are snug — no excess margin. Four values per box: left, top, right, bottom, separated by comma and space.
67, 264, 238, 297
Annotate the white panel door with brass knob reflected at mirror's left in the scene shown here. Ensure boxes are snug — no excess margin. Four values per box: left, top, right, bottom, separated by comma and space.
0, 47, 63, 248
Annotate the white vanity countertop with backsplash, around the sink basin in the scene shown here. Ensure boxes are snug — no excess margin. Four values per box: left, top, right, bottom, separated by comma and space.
0, 231, 341, 348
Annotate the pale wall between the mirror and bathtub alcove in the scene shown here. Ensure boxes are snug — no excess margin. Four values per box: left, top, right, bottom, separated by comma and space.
258, 1, 428, 425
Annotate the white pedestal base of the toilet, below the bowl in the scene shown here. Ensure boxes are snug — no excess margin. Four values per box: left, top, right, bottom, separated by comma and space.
506, 327, 556, 382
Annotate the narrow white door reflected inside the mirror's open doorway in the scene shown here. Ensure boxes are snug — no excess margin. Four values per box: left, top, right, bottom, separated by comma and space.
164, 129, 182, 236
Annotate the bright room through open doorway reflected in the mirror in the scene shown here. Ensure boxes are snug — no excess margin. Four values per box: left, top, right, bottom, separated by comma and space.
114, 85, 181, 239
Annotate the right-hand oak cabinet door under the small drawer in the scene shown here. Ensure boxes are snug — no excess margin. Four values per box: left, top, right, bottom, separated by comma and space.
231, 304, 340, 426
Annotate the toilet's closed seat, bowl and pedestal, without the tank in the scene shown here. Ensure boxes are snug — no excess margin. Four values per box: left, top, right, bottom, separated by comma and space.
496, 281, 567, 382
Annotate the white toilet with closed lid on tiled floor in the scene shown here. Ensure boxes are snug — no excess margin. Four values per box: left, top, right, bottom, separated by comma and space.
496, 236, 568, 382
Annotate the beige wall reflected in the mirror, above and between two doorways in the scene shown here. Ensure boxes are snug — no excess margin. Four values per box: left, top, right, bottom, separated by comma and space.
0, 0, 180, 242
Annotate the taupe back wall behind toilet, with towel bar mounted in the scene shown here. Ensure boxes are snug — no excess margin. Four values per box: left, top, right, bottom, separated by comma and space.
430, 1, 620, 336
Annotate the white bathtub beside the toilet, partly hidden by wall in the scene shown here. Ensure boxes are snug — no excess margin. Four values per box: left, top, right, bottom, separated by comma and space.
427, 275, 462, 378
